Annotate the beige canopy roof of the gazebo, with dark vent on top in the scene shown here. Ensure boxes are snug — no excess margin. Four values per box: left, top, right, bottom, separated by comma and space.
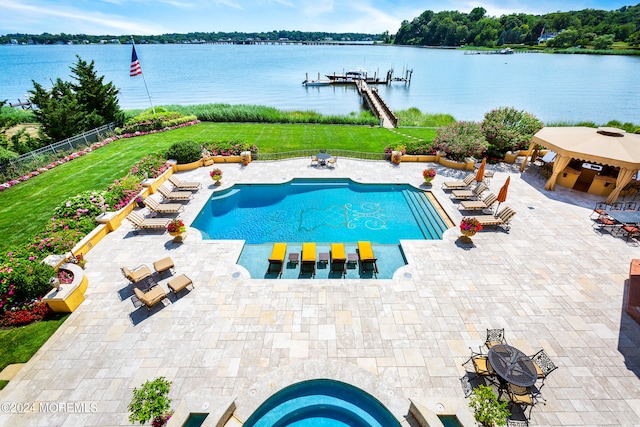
532, 126, 640, 170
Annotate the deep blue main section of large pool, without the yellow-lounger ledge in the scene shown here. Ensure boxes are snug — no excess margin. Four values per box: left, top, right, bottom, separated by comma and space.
191, 179, 446, 244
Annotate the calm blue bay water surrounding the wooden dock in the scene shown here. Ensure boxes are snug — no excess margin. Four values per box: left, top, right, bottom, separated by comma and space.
0, 45, 640, 123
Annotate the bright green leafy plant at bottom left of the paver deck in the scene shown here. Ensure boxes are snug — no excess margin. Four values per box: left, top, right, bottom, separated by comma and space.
128, 377, 173, 427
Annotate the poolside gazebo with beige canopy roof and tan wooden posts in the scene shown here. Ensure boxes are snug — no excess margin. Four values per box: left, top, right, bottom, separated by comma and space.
520, 126, 640, 204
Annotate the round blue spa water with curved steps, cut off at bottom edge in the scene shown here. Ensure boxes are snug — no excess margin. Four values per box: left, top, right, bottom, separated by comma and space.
244, 379, 400, 427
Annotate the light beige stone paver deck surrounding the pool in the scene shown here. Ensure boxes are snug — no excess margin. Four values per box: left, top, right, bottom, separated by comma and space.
0, 159, 640, 427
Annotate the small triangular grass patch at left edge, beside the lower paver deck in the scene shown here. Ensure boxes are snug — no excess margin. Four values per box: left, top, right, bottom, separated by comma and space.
0, 315, 68, 371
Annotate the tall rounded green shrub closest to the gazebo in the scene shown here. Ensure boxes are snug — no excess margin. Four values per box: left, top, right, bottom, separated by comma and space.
482, 107, 544, 157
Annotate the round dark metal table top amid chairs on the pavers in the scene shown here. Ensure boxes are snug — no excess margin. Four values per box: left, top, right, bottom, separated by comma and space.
488, 344, 538, 387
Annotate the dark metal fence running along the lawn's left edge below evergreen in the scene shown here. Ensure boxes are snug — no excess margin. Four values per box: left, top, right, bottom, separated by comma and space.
0, 122, 116, 178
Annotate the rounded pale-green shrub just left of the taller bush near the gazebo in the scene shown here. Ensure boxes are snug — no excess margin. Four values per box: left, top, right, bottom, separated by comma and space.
433, 121, 489, 161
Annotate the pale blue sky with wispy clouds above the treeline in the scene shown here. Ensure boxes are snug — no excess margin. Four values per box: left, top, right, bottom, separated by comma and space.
0, 0, 634, 35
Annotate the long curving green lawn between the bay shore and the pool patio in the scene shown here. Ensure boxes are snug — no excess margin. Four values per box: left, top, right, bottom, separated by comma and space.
0, 122, 435, 252
